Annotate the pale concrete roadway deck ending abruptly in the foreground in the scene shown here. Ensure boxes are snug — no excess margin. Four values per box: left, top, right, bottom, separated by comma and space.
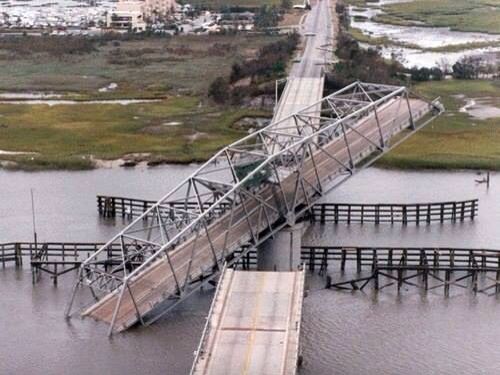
191, 269, 305, 375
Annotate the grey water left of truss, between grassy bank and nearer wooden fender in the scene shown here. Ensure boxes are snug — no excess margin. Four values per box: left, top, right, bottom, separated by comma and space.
0, 165, 196, 242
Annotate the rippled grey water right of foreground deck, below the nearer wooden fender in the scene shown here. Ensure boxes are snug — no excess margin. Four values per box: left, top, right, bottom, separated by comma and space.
300, 282, 500, 375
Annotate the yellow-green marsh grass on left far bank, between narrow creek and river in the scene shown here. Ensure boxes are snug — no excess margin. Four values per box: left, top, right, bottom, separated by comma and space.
0, 97, 269, 169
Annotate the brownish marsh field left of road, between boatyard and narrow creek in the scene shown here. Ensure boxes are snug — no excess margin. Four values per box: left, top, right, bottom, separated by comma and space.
0, 34, 281, 99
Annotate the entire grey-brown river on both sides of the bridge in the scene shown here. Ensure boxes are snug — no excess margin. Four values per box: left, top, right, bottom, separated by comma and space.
0, 165, 500, 375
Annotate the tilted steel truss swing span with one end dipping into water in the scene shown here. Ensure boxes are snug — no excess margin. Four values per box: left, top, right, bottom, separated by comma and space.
65, 82, 443, 334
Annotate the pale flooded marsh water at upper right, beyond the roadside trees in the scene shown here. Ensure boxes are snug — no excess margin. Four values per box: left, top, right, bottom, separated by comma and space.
349, 0, 500, 68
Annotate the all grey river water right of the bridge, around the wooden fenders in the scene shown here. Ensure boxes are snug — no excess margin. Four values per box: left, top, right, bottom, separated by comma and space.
301, 169, 500, 375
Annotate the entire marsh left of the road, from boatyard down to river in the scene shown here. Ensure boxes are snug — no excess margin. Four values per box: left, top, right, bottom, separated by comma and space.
0, 34, 283, 169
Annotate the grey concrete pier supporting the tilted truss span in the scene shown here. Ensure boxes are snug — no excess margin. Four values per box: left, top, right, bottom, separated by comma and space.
257, 223, 305, 271
